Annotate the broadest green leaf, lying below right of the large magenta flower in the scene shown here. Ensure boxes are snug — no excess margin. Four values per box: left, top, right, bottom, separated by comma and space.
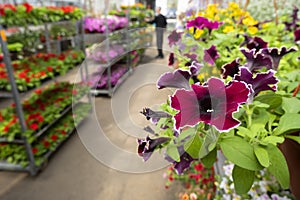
220, 136, 262, 171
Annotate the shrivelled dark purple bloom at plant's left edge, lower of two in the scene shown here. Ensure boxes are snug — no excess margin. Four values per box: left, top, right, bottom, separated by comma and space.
138, 136, 170, 161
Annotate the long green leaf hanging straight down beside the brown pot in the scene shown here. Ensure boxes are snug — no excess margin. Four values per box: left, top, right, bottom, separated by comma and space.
267, 144, 290, 189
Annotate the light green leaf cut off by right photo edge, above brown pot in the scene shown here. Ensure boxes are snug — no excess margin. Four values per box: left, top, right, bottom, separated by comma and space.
274, 113, 300, 135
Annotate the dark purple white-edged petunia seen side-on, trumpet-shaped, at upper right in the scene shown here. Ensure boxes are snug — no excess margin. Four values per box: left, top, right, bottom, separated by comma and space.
261, 47, 297, 70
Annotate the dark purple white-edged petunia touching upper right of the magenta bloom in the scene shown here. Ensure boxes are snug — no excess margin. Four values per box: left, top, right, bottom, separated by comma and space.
234, 67, 278, 97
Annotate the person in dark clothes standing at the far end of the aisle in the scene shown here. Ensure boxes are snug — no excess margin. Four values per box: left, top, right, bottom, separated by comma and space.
150, 7, 167, 58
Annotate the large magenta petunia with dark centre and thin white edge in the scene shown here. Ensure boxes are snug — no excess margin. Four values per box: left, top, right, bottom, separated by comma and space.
170, 78, 250, 131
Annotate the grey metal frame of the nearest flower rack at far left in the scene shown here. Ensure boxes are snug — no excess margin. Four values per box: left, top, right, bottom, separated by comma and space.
0, 7, 91, 175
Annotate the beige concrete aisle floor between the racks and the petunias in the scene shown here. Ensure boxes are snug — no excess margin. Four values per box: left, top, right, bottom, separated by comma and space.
0, 49, 181, 200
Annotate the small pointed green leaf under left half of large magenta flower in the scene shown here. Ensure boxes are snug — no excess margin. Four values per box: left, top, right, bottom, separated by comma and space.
184, 132, 202, 159
